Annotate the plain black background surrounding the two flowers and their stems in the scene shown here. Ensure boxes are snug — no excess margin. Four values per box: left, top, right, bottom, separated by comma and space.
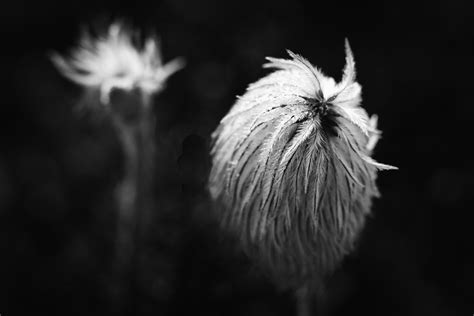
0, 0, 474, 316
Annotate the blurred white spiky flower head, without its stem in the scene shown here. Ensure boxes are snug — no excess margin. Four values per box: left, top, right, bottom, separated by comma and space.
52, 23, 183, 104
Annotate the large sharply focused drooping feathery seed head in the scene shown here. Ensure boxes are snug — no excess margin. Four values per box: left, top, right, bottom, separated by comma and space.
209, 40, 394, 286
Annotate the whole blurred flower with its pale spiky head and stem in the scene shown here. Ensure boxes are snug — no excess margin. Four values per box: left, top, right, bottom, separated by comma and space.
52, 23, 183, 315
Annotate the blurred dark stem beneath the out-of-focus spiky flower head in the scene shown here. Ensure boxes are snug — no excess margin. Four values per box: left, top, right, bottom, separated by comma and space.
113, 93, 155, 314
